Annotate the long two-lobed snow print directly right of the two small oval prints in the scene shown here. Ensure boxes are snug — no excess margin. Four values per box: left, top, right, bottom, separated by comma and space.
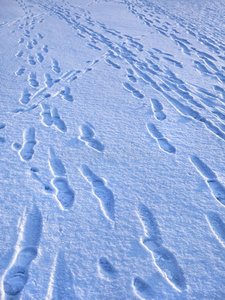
137, 203, 186, 291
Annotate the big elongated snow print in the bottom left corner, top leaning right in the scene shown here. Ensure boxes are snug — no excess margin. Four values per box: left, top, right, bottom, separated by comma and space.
3, 205, 42, 299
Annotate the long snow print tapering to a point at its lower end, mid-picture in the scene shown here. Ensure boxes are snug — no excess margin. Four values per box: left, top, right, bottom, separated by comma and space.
80, 165, 115, 221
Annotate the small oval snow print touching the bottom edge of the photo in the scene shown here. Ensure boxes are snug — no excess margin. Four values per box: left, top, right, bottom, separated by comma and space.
132, 277, 154, 299
